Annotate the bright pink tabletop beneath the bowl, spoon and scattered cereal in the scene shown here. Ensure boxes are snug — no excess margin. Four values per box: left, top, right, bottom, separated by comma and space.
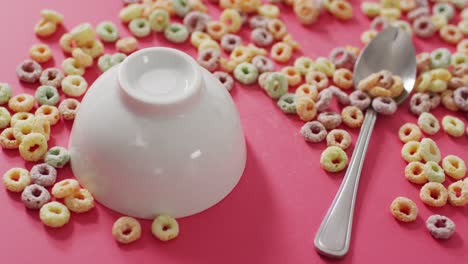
0, 0, 468, 264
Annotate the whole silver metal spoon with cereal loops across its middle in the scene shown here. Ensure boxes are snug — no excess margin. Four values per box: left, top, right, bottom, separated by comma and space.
314, 27, 416, 257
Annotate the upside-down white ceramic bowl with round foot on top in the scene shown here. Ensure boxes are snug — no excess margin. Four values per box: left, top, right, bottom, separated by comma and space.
69, 48, 246, 219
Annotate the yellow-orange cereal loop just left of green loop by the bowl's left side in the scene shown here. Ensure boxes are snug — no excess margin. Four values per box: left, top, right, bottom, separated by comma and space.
19, 133, 47, 161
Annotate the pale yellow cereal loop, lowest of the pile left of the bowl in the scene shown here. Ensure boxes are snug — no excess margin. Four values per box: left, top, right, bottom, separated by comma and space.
39, 201, 70, 228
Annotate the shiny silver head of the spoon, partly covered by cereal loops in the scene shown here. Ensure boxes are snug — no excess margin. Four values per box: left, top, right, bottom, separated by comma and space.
353, 26, 416, 104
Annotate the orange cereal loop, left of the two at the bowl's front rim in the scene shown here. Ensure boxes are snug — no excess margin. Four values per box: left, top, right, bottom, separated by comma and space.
112, 216, 141, 244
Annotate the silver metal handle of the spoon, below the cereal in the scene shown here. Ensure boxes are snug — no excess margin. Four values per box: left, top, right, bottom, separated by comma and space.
315, 108, 377, 257
